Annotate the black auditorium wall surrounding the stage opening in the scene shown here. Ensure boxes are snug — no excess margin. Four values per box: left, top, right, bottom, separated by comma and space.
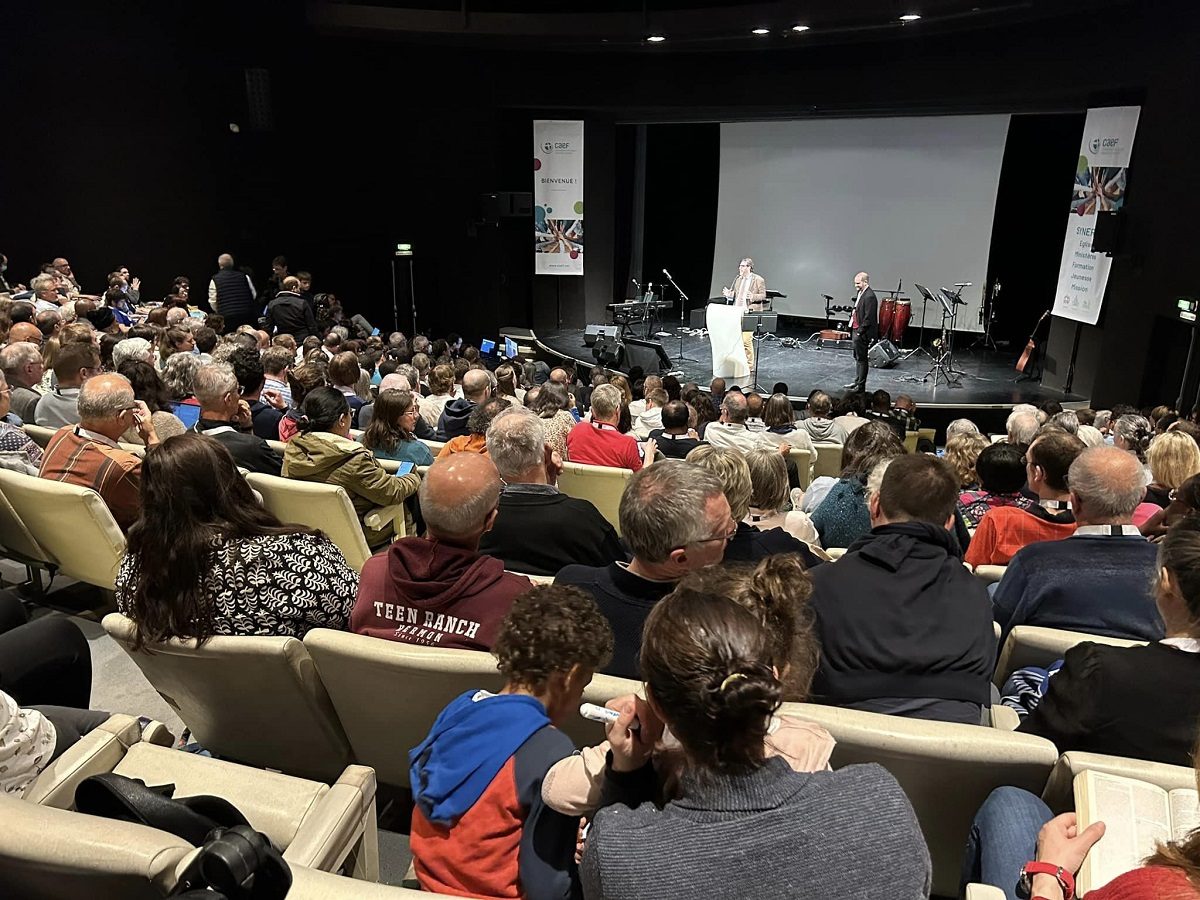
0, 1, 1200, 403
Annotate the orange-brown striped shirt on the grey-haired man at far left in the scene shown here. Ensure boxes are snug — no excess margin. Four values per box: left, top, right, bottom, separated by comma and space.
41, 425, 142, 532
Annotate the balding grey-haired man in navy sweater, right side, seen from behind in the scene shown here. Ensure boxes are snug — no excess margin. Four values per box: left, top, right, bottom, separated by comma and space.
992, 446, 1163, 643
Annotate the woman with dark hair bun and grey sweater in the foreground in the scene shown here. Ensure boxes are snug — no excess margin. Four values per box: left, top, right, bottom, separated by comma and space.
581, 590, 931, 900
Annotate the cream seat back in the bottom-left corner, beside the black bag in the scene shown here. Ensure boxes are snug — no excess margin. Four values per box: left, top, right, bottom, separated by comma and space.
0, 793, 194, 900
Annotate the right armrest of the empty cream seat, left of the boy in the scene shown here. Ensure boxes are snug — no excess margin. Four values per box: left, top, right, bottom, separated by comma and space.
283, 766, 379, 881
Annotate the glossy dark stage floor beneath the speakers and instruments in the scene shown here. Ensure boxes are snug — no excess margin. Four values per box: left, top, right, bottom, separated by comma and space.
535, 324, 1087, 409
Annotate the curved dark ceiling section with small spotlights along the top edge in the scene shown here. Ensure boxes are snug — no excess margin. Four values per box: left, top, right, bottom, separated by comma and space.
307, 0, 1128, 53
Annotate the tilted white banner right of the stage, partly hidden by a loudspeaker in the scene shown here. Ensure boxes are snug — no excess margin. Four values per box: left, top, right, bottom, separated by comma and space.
1054, 107, 1141, 325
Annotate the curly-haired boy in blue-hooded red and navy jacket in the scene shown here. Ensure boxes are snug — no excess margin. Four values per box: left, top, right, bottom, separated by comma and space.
408, 584, 612, 900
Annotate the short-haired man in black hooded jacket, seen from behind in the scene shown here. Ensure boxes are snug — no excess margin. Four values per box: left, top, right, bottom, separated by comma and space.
810, 455, 996, 725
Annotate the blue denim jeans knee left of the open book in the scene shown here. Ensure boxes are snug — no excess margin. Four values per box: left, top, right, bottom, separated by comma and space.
962, 787, 1054, 900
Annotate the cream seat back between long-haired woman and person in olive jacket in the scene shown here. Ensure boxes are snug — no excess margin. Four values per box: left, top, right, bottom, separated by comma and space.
246, 473, 404, 571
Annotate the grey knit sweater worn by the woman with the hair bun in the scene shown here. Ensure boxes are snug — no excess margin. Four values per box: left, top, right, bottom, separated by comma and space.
581, 757, 931, 900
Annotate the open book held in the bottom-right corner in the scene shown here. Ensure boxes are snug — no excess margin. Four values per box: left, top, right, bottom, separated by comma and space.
1075, 770, 1200, 896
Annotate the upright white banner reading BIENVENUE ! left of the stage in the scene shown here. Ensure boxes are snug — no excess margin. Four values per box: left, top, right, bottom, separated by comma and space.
533, 119, 583, 275
